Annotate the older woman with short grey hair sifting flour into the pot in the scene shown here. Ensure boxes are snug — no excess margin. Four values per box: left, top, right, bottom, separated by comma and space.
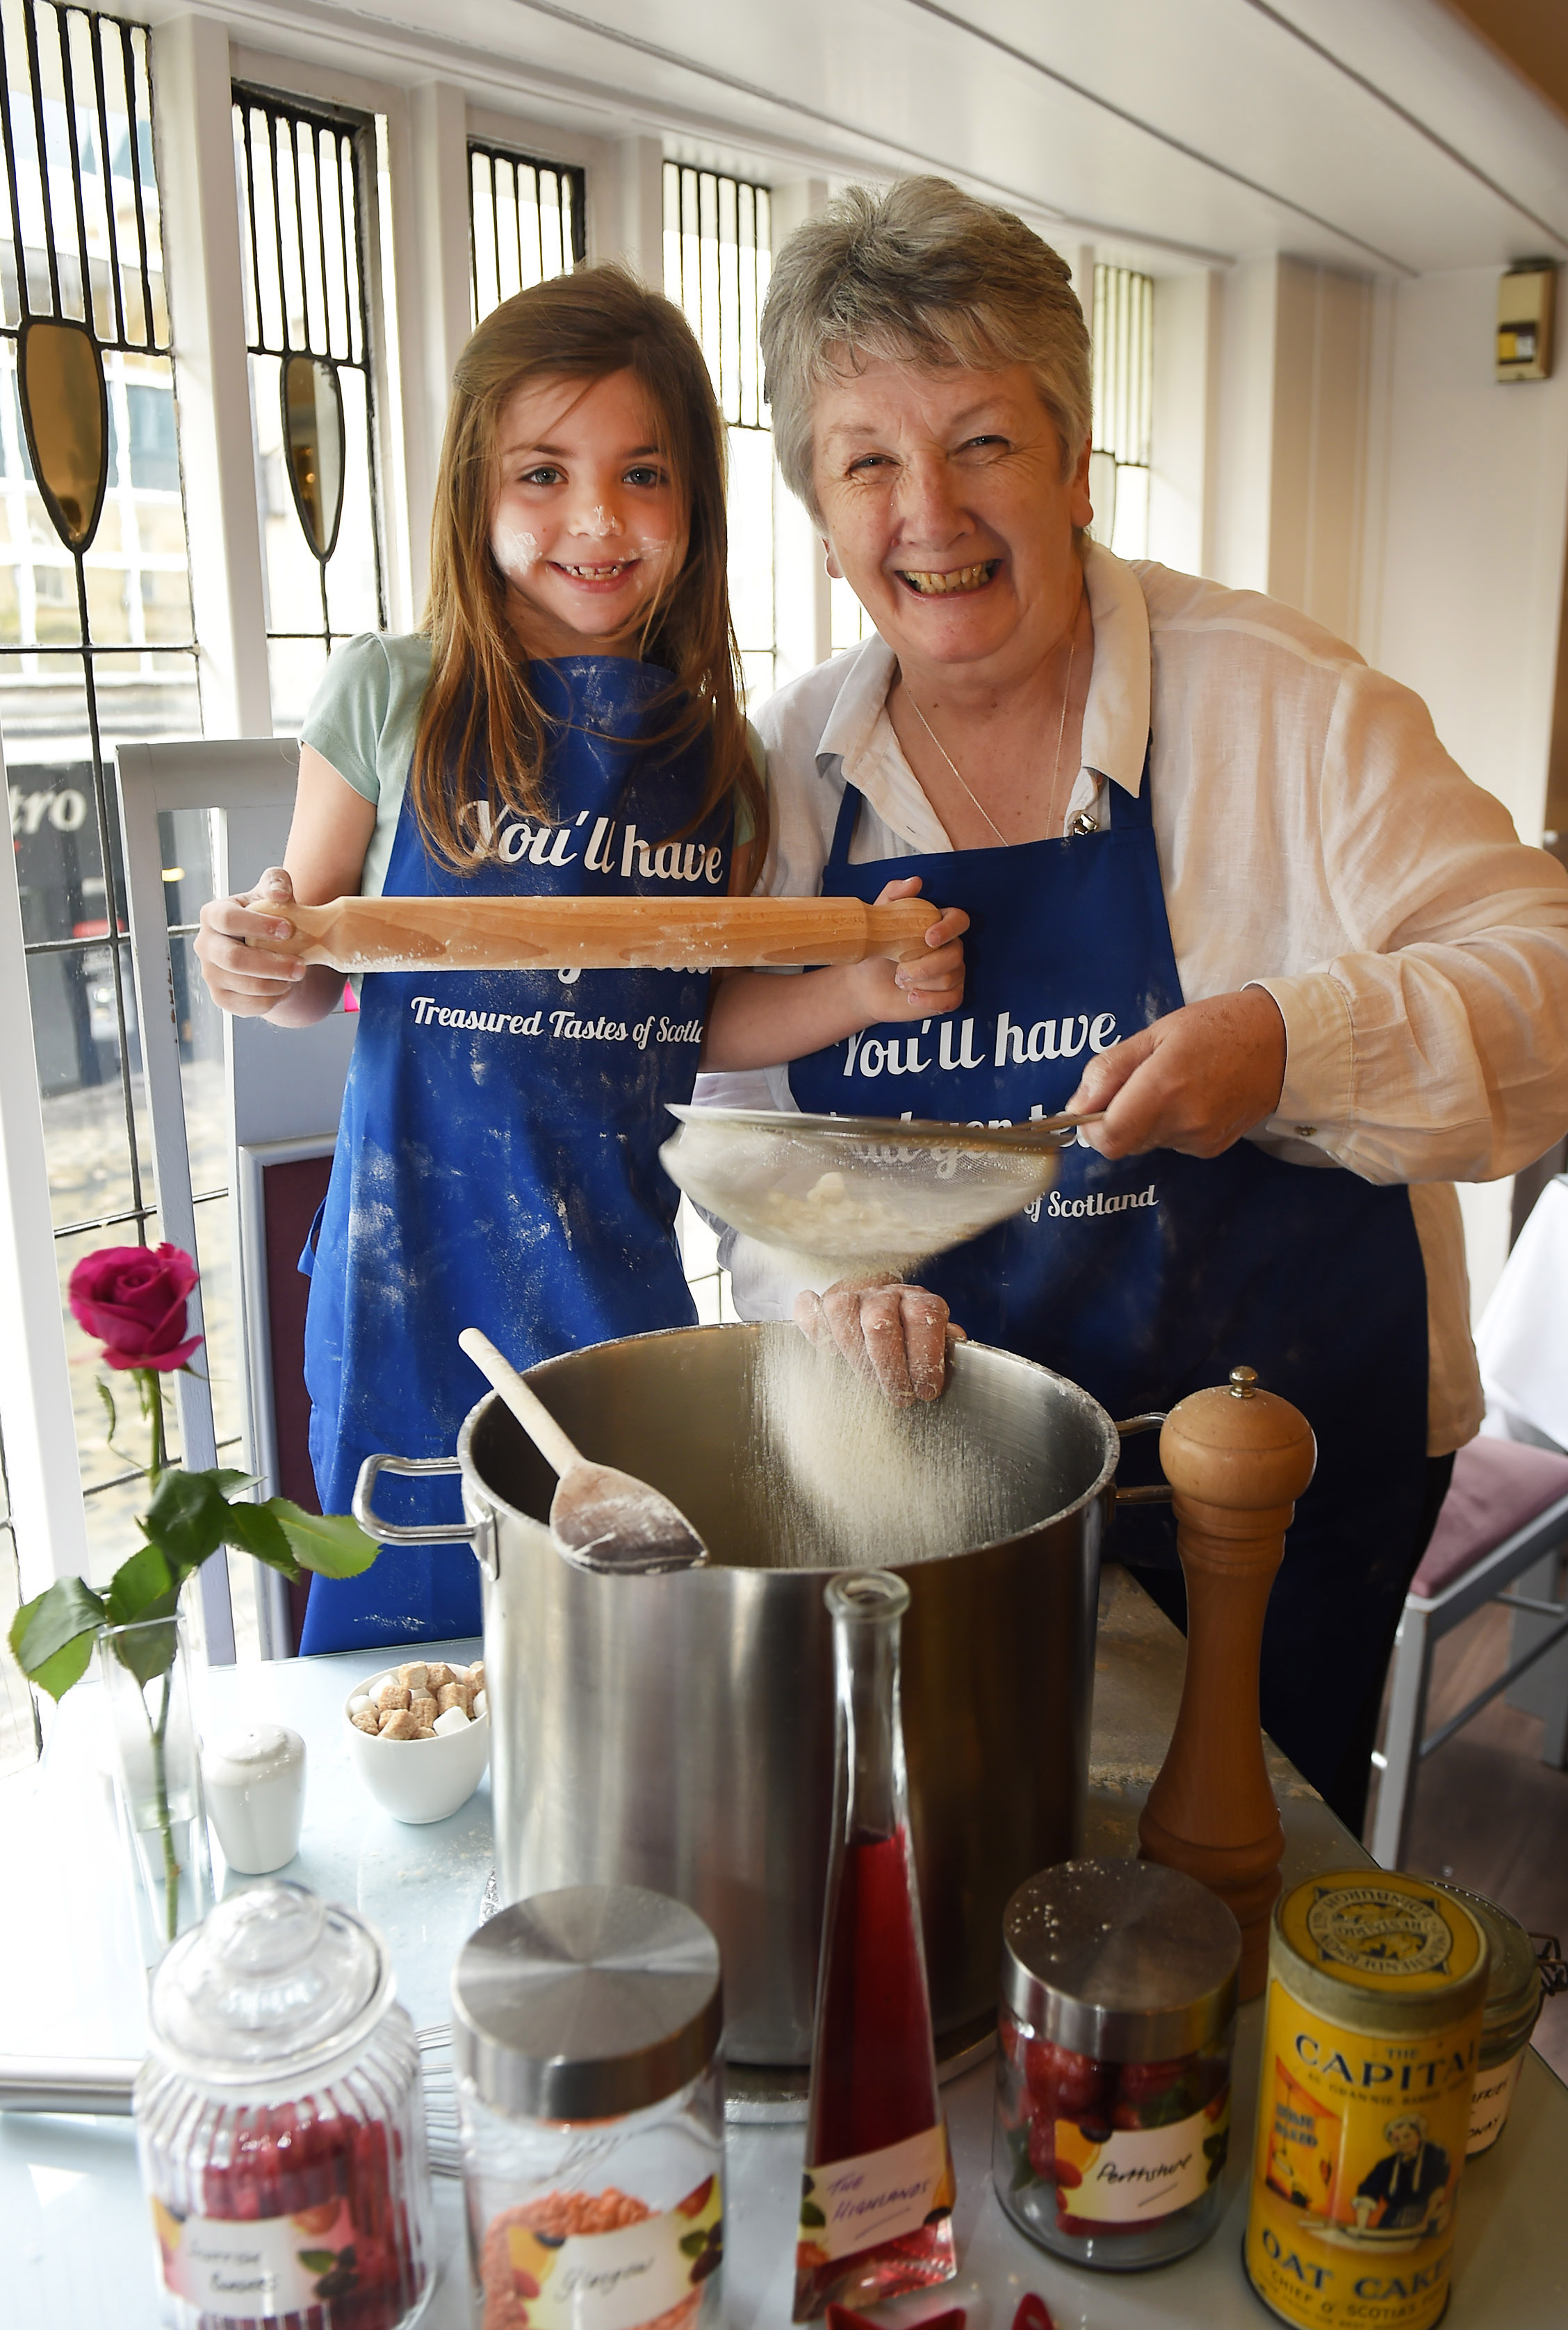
708, 179, 1568, 1827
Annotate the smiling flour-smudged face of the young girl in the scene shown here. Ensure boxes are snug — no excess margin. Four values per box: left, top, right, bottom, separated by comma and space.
489, 373, 687, 657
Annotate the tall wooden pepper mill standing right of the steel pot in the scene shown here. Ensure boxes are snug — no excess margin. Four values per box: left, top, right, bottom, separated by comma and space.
1137, 1368, 1316, 1999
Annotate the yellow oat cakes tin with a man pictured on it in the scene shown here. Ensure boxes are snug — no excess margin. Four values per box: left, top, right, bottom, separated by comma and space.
1246, 1868, 1487, 2330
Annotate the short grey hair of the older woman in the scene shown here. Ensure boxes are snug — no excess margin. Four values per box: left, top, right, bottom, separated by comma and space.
762, 177, 1093, 517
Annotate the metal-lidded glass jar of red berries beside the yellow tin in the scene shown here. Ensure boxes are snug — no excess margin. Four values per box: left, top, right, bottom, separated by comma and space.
993, 1861, 1242, 2272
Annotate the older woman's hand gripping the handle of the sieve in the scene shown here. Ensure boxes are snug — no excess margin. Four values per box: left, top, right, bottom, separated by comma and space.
1067, 988, 1286, 1158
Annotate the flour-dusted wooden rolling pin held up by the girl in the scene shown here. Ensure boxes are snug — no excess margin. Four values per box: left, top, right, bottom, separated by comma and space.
259, 895, 941, 972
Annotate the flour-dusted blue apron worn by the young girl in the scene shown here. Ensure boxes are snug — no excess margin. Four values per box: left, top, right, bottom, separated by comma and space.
300, 657, 732, 1652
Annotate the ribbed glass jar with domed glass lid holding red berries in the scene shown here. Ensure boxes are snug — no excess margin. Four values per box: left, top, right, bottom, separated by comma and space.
135, 1880, 434, 2330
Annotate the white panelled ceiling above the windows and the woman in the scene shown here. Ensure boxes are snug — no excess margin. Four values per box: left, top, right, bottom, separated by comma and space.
183, 0, 1568, 272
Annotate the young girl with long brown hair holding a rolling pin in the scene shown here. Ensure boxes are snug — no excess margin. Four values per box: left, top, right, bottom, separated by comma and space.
196, 266, 962, 1652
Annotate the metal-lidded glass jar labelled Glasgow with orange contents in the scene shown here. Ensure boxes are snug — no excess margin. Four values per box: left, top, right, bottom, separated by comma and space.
452, 1885, 725, 2330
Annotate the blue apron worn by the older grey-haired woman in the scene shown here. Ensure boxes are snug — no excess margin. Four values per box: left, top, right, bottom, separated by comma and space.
790, 760, 1426, 1787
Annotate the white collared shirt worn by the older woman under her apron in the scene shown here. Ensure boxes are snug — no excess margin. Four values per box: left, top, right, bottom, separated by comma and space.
699, 543, 1568, 1454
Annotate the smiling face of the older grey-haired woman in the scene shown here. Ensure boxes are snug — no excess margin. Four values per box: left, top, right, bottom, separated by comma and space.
811, 357, 1093, 683
